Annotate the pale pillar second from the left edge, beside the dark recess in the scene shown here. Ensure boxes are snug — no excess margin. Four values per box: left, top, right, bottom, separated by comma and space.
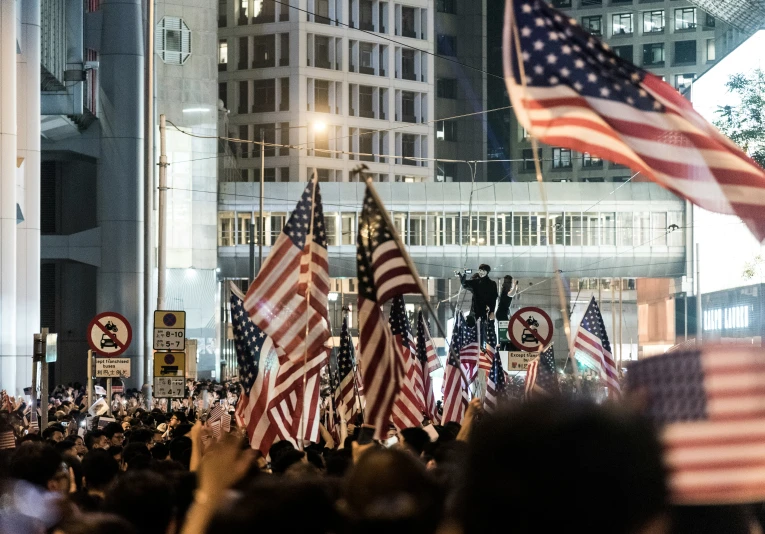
16, 0, 40, 396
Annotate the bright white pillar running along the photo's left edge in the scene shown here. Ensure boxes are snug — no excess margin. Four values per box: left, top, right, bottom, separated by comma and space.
0, 0, 18, 394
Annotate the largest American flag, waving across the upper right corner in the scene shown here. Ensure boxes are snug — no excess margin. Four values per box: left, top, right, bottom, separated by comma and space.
503, 0, 765, 241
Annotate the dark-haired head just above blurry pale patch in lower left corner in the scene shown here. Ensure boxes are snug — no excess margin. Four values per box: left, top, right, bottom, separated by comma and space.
9, 442, 69, 493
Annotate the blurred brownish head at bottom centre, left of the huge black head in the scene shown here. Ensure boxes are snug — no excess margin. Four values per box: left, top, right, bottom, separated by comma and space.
342, 449, 442, 534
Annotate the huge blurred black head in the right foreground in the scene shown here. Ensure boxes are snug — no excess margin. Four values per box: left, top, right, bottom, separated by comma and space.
459, 399, 668, 534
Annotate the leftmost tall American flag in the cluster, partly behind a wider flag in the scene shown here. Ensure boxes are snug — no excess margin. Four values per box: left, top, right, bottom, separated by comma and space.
231, 284, 277, 455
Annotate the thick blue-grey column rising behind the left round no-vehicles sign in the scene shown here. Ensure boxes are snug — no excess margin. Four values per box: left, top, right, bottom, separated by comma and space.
96, 0, 145, 387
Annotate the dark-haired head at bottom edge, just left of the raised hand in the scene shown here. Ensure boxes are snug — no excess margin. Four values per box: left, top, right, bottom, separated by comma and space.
104, 470, 175, 534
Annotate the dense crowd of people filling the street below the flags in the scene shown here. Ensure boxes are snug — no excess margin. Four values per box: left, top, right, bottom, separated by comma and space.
0, 383, 763, 534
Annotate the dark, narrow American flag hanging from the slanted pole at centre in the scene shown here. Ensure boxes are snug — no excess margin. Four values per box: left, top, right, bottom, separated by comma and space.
356, 184, 420, 439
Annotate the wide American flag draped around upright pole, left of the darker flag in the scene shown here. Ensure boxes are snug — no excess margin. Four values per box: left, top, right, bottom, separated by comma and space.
244, 177, 330, 361
